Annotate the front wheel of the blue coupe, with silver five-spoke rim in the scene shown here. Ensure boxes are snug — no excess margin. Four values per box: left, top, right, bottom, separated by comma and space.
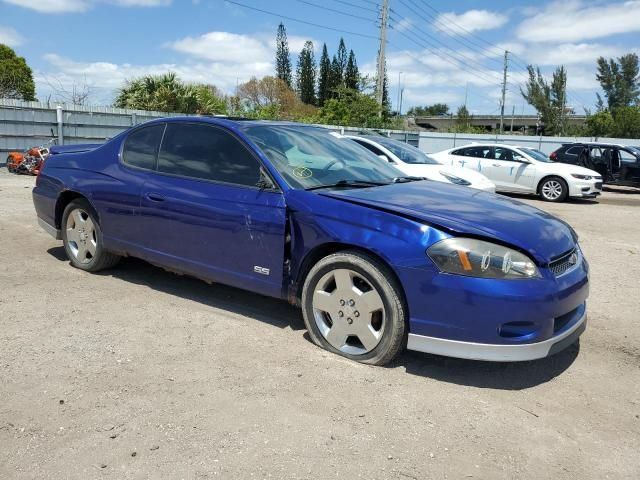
302, 251, 407, 365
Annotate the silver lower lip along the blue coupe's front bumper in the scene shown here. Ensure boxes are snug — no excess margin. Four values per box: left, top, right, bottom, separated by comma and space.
407, 310, 587, 362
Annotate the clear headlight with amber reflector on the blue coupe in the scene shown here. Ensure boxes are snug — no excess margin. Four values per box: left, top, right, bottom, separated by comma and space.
427, 238, 540, 279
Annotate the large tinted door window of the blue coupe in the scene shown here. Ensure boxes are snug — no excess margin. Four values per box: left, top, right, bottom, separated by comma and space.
158, 123, 260, 186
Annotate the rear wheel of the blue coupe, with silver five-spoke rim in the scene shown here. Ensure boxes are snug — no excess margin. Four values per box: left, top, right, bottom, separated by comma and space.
61, 199, 120, 272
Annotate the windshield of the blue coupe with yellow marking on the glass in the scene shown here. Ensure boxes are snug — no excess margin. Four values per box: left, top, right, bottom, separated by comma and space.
244, 125, 403, 189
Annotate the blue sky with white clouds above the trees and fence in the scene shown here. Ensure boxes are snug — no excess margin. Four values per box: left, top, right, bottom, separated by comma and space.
0, 0, 640, 114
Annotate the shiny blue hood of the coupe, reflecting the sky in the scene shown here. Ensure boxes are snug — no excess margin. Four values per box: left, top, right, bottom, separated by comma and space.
320, 180, 576, 264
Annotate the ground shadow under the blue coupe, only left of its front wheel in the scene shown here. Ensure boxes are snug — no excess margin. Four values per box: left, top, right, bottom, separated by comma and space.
47, 247, 304, 330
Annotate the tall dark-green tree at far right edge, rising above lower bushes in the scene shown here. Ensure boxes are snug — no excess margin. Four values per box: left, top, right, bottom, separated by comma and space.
596, 53, 640, 111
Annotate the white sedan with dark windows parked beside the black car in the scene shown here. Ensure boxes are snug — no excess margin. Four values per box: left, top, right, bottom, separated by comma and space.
432, 144, 602, 202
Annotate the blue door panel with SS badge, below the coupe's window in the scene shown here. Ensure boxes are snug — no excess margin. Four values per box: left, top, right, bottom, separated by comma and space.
141, 173, 285, 296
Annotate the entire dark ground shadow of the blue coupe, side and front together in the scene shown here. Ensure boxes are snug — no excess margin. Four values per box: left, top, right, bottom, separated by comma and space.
47, 247, 580, 390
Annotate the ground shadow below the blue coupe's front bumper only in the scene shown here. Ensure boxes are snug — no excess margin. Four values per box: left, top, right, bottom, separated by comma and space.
390, 342, 580, 390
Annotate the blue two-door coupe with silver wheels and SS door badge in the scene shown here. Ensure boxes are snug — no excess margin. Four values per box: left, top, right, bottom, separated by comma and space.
33, 118, 589, 365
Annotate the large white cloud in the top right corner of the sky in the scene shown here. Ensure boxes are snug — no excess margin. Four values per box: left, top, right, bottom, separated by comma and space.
517, 0, 640, 43
